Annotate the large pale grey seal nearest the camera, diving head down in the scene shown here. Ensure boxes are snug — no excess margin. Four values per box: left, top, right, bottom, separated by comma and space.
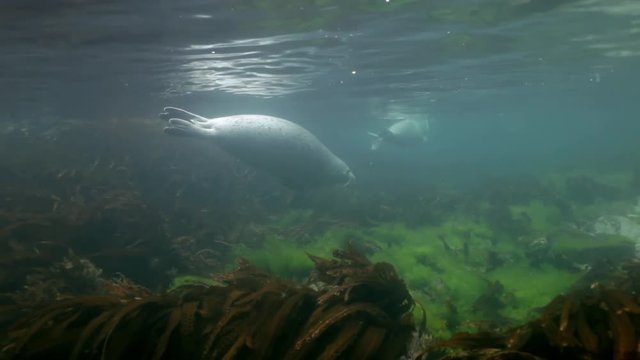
160, 107, 355, 188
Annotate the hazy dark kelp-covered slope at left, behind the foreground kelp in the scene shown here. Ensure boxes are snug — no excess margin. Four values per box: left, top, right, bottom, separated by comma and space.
0, 119, 277, 293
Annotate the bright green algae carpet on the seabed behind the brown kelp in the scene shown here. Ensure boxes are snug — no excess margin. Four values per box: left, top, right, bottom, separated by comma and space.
221, 170, 634, 338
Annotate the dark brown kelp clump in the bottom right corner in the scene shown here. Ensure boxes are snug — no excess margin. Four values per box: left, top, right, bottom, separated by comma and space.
419, 261, 640, 360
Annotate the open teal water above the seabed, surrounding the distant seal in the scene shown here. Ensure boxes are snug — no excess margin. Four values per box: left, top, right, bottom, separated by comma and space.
0, 0, 640, 187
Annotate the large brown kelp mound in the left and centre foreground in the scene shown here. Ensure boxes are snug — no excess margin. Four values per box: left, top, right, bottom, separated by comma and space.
0, 248, 415, 360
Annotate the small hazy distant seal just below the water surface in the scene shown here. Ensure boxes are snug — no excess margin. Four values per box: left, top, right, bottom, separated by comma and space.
369, 120, 429, 150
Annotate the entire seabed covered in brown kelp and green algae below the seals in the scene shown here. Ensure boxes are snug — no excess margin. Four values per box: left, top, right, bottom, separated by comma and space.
0, 119, 640, 359
